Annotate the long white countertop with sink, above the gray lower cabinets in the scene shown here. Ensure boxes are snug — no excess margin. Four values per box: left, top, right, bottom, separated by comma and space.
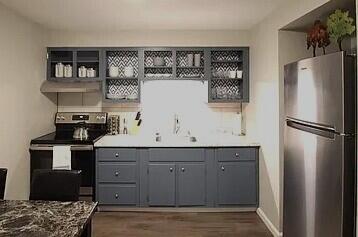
94, 135, 260, 147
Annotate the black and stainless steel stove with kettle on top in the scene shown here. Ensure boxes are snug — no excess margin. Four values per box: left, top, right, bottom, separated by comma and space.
30, 113, 107, 200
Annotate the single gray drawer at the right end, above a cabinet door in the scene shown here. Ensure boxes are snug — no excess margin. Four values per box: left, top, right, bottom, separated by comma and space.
218, 148, 256, 161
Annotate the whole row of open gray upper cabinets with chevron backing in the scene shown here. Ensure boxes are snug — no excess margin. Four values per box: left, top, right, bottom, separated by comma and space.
47, 47, 250, 103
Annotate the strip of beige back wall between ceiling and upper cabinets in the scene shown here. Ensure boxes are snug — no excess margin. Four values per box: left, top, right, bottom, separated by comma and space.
48, 30, 250, 46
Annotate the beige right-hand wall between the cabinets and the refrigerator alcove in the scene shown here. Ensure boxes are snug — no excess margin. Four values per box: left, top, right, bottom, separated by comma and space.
246, 0, 328, 235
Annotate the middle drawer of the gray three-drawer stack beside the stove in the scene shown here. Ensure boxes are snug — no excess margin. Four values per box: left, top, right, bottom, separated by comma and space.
98, 162, 137, 183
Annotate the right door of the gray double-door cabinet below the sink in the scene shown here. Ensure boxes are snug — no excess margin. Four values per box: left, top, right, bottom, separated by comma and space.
177, 163, 206, 206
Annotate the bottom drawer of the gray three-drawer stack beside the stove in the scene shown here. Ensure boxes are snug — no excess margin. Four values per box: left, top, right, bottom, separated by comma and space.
98, 184, 137, 205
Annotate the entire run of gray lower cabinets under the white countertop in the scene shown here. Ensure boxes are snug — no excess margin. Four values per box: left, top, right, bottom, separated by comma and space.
96, 147, 259, 207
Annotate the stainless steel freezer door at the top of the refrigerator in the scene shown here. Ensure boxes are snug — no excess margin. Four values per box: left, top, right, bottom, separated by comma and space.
284, 52, 355, 133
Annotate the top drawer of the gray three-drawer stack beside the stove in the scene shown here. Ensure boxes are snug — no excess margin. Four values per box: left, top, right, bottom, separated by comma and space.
97, 148, 137, 161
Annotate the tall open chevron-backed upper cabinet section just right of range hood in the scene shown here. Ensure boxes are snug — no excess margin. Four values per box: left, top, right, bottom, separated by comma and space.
104, 48, 140, 103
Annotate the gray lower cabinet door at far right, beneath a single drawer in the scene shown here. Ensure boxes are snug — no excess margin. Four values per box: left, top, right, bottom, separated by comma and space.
217, 162, 257, 205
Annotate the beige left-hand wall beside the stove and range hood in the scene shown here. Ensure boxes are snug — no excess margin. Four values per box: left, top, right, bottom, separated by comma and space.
0, 4, 56, 199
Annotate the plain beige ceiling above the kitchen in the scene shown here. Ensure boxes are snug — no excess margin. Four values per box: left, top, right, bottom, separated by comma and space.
0, 0, 287, 31
